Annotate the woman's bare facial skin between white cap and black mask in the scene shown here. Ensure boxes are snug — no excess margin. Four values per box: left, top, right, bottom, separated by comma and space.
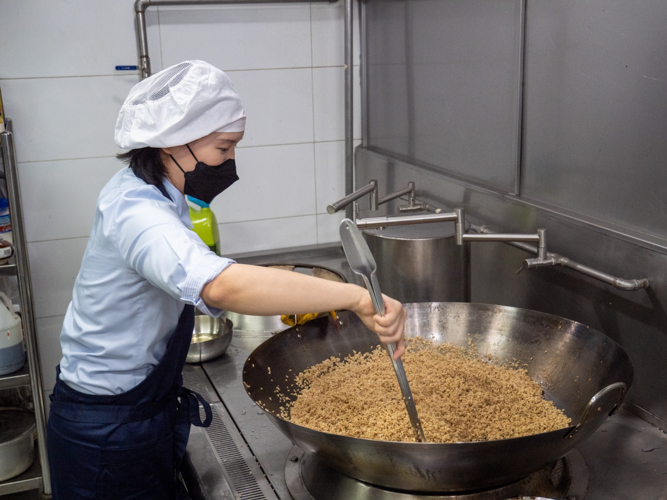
160, 132, 243, 192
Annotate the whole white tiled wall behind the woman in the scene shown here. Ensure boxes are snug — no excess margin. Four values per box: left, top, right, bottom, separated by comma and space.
0, 0, 360, 391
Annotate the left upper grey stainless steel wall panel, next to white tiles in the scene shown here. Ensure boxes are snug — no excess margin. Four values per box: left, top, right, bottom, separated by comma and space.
368, 0, 522, 192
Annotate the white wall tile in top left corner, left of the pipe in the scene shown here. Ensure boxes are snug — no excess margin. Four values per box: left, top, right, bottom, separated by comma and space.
0, 0, 137, 78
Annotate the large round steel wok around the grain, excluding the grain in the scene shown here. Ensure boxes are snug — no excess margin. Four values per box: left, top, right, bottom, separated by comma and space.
243, 303, 633, 492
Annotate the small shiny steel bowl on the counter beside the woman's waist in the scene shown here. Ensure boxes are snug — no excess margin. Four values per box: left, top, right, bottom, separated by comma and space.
185, 314, 234, 363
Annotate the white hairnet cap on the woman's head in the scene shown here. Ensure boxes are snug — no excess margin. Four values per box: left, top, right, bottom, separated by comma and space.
114, 61, 246, 149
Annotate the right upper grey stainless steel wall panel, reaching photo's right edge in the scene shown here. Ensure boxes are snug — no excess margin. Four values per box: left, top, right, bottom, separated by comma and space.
522, 0, 667, 241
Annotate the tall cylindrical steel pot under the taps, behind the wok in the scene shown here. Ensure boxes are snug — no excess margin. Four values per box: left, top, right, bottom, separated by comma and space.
362, 222, 466, 303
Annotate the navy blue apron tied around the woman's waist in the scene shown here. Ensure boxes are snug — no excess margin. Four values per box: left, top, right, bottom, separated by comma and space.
47, 181, 212, 500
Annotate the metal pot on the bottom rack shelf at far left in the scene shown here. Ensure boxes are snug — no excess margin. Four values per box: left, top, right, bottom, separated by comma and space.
0, 408, 35, 481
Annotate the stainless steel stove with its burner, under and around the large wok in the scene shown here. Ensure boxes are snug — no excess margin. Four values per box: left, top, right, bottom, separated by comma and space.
184, 249, 667, 500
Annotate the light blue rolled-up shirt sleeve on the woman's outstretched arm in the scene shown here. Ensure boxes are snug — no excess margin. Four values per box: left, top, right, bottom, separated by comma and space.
108, 186, 234, 316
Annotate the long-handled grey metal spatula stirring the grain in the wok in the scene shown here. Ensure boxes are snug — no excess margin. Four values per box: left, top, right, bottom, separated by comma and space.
340, 219, 426, 442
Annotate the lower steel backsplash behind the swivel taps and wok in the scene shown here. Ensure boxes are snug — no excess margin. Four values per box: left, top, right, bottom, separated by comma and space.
356, 148, 667, 424
